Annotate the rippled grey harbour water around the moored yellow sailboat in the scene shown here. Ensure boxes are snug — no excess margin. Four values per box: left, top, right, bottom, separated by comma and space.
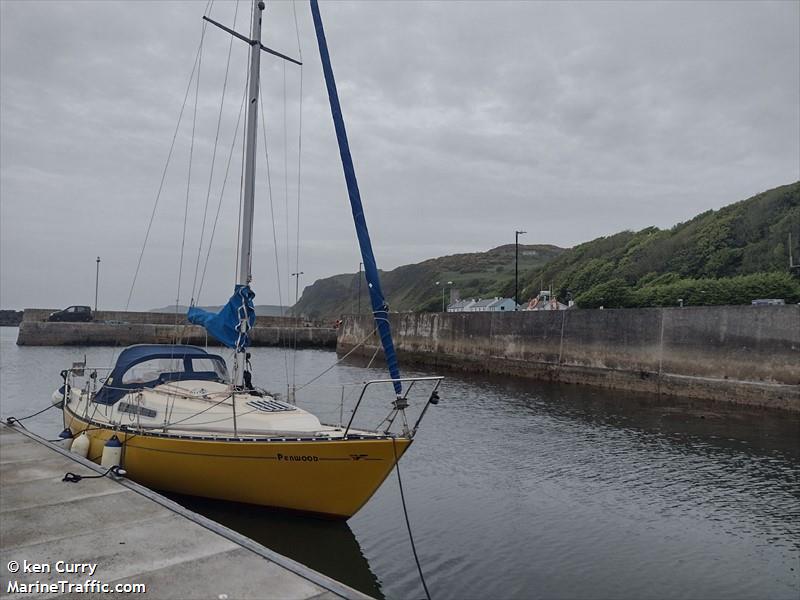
0, 328, 800, 599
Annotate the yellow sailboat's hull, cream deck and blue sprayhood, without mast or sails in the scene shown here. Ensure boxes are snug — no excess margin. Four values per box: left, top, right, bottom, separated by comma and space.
57, 345, 439, 518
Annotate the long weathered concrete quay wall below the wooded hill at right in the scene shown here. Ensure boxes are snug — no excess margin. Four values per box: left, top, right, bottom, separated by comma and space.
337, 305, 800, 411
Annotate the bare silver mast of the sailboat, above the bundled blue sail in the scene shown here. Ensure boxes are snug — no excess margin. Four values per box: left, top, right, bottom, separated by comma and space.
236, 0, 264, 285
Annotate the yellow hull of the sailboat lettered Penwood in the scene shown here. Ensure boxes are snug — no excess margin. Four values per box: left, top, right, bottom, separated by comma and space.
64, 410, 411, 519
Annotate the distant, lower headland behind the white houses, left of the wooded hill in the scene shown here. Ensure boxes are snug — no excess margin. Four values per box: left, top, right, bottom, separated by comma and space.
293, 244, 564, 318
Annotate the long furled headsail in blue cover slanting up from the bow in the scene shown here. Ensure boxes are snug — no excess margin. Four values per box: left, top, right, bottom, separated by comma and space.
311, 0, 403, 395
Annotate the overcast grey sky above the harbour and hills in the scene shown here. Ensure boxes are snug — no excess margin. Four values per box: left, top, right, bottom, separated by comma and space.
0, 0, 800, 309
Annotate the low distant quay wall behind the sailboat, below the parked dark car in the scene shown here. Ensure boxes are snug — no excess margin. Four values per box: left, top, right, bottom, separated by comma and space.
17, 319, 336, 348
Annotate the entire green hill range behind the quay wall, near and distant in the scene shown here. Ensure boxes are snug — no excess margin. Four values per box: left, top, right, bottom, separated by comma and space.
295, 182, 800, 318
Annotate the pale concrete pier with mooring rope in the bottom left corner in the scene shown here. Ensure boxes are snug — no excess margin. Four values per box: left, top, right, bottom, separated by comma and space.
0, 424, 376, 600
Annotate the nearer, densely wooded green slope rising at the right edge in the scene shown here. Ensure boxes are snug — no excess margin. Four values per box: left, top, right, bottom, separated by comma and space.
523, 182, 800, 306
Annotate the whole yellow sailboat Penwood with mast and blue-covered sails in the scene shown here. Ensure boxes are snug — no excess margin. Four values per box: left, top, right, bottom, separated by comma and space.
54, 0, 442, 518
